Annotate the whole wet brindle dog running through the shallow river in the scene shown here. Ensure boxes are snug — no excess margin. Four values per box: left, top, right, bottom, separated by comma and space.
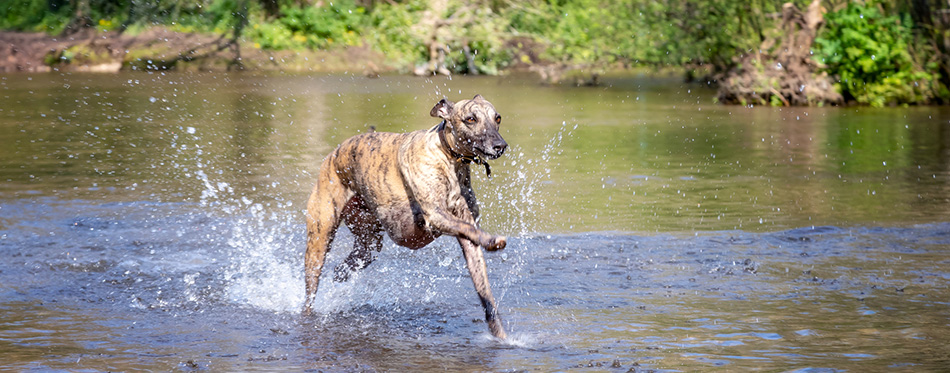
304, 95, 508, 339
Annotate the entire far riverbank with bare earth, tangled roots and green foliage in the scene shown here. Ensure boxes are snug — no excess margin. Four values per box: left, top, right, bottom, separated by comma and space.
0, 0, 950, 106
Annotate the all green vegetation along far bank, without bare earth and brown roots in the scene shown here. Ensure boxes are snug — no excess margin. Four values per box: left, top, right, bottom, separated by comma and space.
0, 0, 950, 106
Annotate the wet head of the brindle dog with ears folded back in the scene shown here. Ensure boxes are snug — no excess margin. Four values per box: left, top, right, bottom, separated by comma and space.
429, 95, 508, 159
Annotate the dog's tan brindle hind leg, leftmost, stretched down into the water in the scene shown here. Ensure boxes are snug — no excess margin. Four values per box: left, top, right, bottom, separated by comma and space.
303, 160, 353, 315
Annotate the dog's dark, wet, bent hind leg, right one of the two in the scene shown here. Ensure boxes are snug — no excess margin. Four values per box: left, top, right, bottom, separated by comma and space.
333, 196, 383, 282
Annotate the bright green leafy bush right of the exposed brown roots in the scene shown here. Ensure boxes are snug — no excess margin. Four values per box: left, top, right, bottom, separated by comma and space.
815, 3, 936, 106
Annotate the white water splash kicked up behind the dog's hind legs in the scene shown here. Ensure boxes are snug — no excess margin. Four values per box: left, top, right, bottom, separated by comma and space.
164, 123, 304, 312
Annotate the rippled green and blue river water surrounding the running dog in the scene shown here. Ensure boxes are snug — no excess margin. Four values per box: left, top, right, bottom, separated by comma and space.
0, 73, 950, 372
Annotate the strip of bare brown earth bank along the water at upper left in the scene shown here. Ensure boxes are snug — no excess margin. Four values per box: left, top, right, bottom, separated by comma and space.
0, 27, 392, 75
